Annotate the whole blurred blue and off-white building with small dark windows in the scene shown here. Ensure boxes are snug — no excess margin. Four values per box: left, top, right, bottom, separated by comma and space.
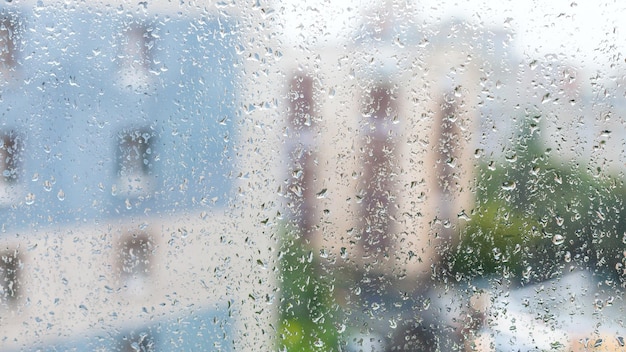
0, 3, 270, 351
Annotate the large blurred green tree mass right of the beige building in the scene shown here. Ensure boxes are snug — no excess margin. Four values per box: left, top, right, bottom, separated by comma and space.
450, 116, 626, 284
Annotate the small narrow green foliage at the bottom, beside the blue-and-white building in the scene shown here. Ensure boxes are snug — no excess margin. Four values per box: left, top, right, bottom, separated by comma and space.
278, 226, 339, 351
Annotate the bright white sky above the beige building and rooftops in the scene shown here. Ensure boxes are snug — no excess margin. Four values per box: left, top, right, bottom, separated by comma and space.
275, 0, 626, 69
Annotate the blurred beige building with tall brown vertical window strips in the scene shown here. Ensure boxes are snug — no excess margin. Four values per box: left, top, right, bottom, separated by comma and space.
267, 4, 483, 350
